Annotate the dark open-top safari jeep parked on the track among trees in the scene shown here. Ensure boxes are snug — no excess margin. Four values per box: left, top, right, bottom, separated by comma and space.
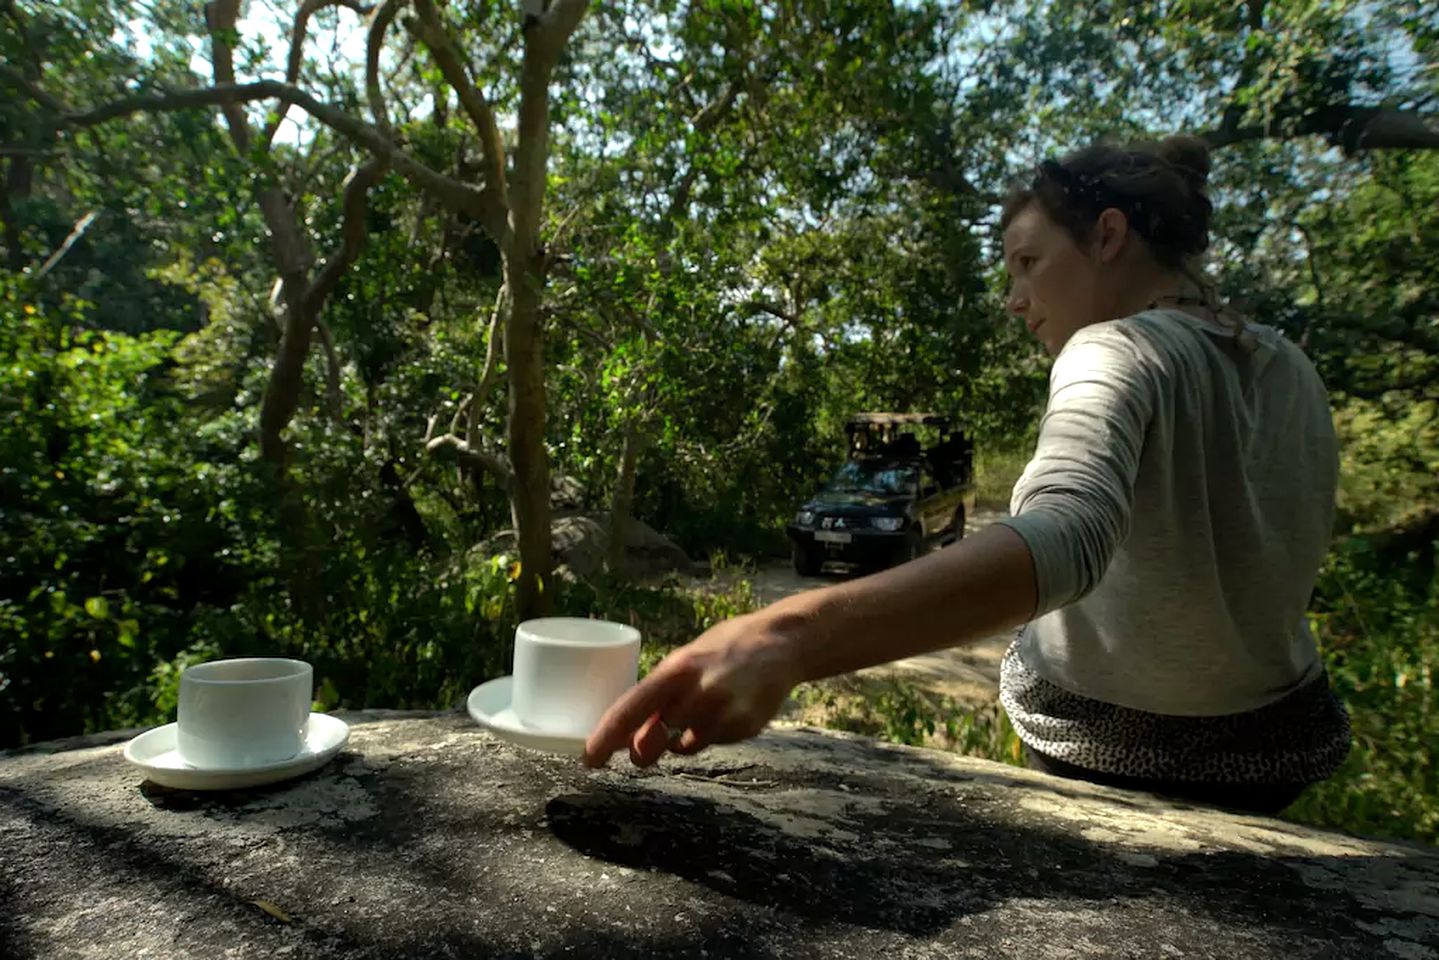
789, 413, 974, 577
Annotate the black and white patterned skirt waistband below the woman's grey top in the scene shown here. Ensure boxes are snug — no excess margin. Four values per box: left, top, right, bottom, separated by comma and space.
999, 643, 1350, 784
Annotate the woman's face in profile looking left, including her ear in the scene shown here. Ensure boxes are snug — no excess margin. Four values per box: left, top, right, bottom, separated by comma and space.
1004, 203, 1127, 356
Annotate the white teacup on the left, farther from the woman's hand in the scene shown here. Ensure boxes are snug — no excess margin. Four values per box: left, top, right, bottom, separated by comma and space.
176, 656, 315, 770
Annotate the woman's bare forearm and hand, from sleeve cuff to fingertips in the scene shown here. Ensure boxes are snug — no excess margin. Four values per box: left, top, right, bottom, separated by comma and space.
584, 524, 1039, 767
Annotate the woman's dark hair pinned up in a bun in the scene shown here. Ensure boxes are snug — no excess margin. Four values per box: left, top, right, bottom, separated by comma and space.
1000, 137, 1215, 269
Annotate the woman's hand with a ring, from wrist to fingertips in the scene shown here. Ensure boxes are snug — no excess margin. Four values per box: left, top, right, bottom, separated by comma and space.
584, 612, 803, 767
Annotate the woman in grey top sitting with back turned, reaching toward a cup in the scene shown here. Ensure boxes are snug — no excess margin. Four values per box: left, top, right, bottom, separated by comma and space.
586, 138, 1350, 812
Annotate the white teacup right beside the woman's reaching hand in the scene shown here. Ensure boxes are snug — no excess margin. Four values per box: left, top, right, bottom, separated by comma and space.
511, 617, 639, 737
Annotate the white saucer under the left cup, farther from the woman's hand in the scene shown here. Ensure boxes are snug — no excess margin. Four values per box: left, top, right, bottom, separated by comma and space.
125, 714, 350, 790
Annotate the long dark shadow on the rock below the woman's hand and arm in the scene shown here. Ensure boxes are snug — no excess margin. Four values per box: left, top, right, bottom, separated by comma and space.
547, 787, 1427, 957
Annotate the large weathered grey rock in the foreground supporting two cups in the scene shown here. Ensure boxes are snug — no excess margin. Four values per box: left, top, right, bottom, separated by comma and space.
0, 711, 1439, 960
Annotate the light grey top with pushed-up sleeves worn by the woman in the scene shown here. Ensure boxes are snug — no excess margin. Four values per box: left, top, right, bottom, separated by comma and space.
1002, 309, 1338, 715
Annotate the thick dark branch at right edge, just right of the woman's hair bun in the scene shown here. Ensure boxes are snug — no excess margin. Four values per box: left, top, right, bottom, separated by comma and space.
1203, 104, 1439, 154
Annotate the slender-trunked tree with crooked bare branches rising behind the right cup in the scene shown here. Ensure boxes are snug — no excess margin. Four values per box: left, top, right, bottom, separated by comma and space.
0, 0, 587, 615
